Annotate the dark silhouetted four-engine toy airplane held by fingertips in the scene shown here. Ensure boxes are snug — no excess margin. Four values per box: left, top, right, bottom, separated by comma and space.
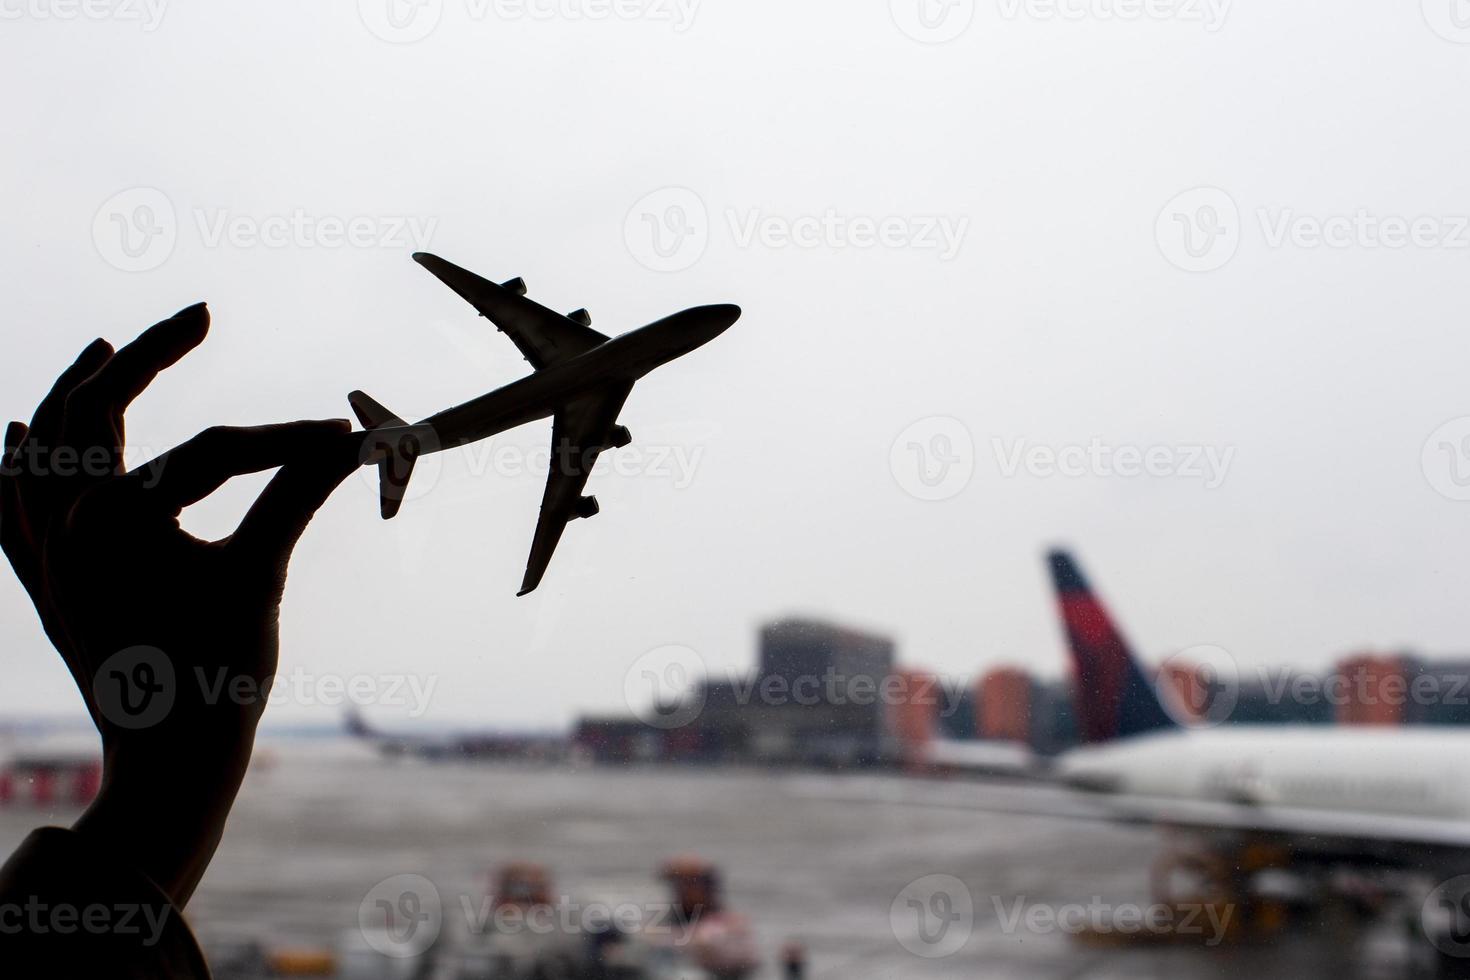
347, 251, 739, 595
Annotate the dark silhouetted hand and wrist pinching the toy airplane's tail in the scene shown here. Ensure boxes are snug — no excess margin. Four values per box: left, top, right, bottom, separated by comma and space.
0, 304, 359, 907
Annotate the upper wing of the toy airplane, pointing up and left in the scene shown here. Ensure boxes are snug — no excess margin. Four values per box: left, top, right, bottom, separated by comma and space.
413, 251, 607, 370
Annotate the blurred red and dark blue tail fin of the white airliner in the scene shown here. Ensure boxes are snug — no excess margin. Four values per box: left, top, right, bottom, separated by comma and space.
1047, 550, 1177, 742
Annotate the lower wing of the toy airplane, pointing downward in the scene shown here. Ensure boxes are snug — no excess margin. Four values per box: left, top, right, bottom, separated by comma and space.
516, 385, 632, 595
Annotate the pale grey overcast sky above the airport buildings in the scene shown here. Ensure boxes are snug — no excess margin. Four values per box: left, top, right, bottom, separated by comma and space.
0, 0, 1470, 727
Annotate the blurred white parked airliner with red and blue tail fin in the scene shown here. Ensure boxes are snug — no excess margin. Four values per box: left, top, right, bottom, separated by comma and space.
1048, 551, 1470, 865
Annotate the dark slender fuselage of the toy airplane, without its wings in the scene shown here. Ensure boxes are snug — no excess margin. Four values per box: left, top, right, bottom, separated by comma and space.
375, 307, 738, 455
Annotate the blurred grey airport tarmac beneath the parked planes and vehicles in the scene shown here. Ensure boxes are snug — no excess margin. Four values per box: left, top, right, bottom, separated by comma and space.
0, 741, 1446, 980
